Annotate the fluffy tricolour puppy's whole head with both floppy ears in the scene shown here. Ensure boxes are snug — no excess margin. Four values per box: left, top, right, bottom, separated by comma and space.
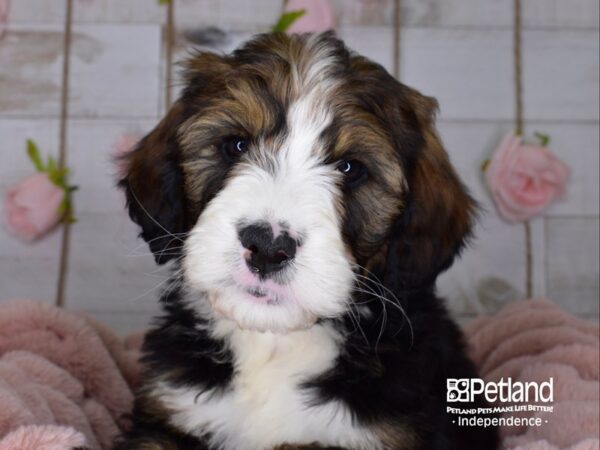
122, 34, 472, 332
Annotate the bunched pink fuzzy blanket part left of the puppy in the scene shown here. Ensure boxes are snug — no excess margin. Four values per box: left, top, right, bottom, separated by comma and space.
0, 300, 139, 450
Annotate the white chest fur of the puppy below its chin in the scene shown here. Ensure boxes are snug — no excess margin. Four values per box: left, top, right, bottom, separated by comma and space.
154, 325, 381, 450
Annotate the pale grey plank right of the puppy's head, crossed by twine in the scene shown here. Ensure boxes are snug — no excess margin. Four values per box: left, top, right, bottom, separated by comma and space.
400, 28, 599, 121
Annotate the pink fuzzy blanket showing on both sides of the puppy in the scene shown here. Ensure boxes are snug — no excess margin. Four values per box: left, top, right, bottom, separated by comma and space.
0, 300, 600, 450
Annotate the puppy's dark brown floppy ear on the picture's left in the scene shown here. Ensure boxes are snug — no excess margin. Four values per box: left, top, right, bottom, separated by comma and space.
119, 102, 188, 264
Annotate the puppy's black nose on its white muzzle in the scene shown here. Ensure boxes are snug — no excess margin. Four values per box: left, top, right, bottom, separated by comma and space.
238, 224, 297, 277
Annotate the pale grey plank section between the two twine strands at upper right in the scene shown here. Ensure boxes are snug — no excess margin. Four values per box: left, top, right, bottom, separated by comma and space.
400, 28, 514, 120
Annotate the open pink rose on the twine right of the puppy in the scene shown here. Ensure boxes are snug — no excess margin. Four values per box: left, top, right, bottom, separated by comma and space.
485, 134, 569, 222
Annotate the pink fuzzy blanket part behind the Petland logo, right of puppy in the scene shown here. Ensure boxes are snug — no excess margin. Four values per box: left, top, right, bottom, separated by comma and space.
465, 299, 600, 450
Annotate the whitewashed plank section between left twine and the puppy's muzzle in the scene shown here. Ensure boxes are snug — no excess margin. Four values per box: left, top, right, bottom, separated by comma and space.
66, 211, 169, 312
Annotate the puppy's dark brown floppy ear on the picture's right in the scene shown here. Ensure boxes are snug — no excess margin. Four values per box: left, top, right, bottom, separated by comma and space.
386, 86, 476, 290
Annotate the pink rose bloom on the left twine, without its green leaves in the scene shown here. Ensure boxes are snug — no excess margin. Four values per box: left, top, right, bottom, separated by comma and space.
4, 172, 65, 241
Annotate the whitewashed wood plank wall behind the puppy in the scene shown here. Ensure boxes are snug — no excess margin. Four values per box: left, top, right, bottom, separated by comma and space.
0, 0, 599, 331
